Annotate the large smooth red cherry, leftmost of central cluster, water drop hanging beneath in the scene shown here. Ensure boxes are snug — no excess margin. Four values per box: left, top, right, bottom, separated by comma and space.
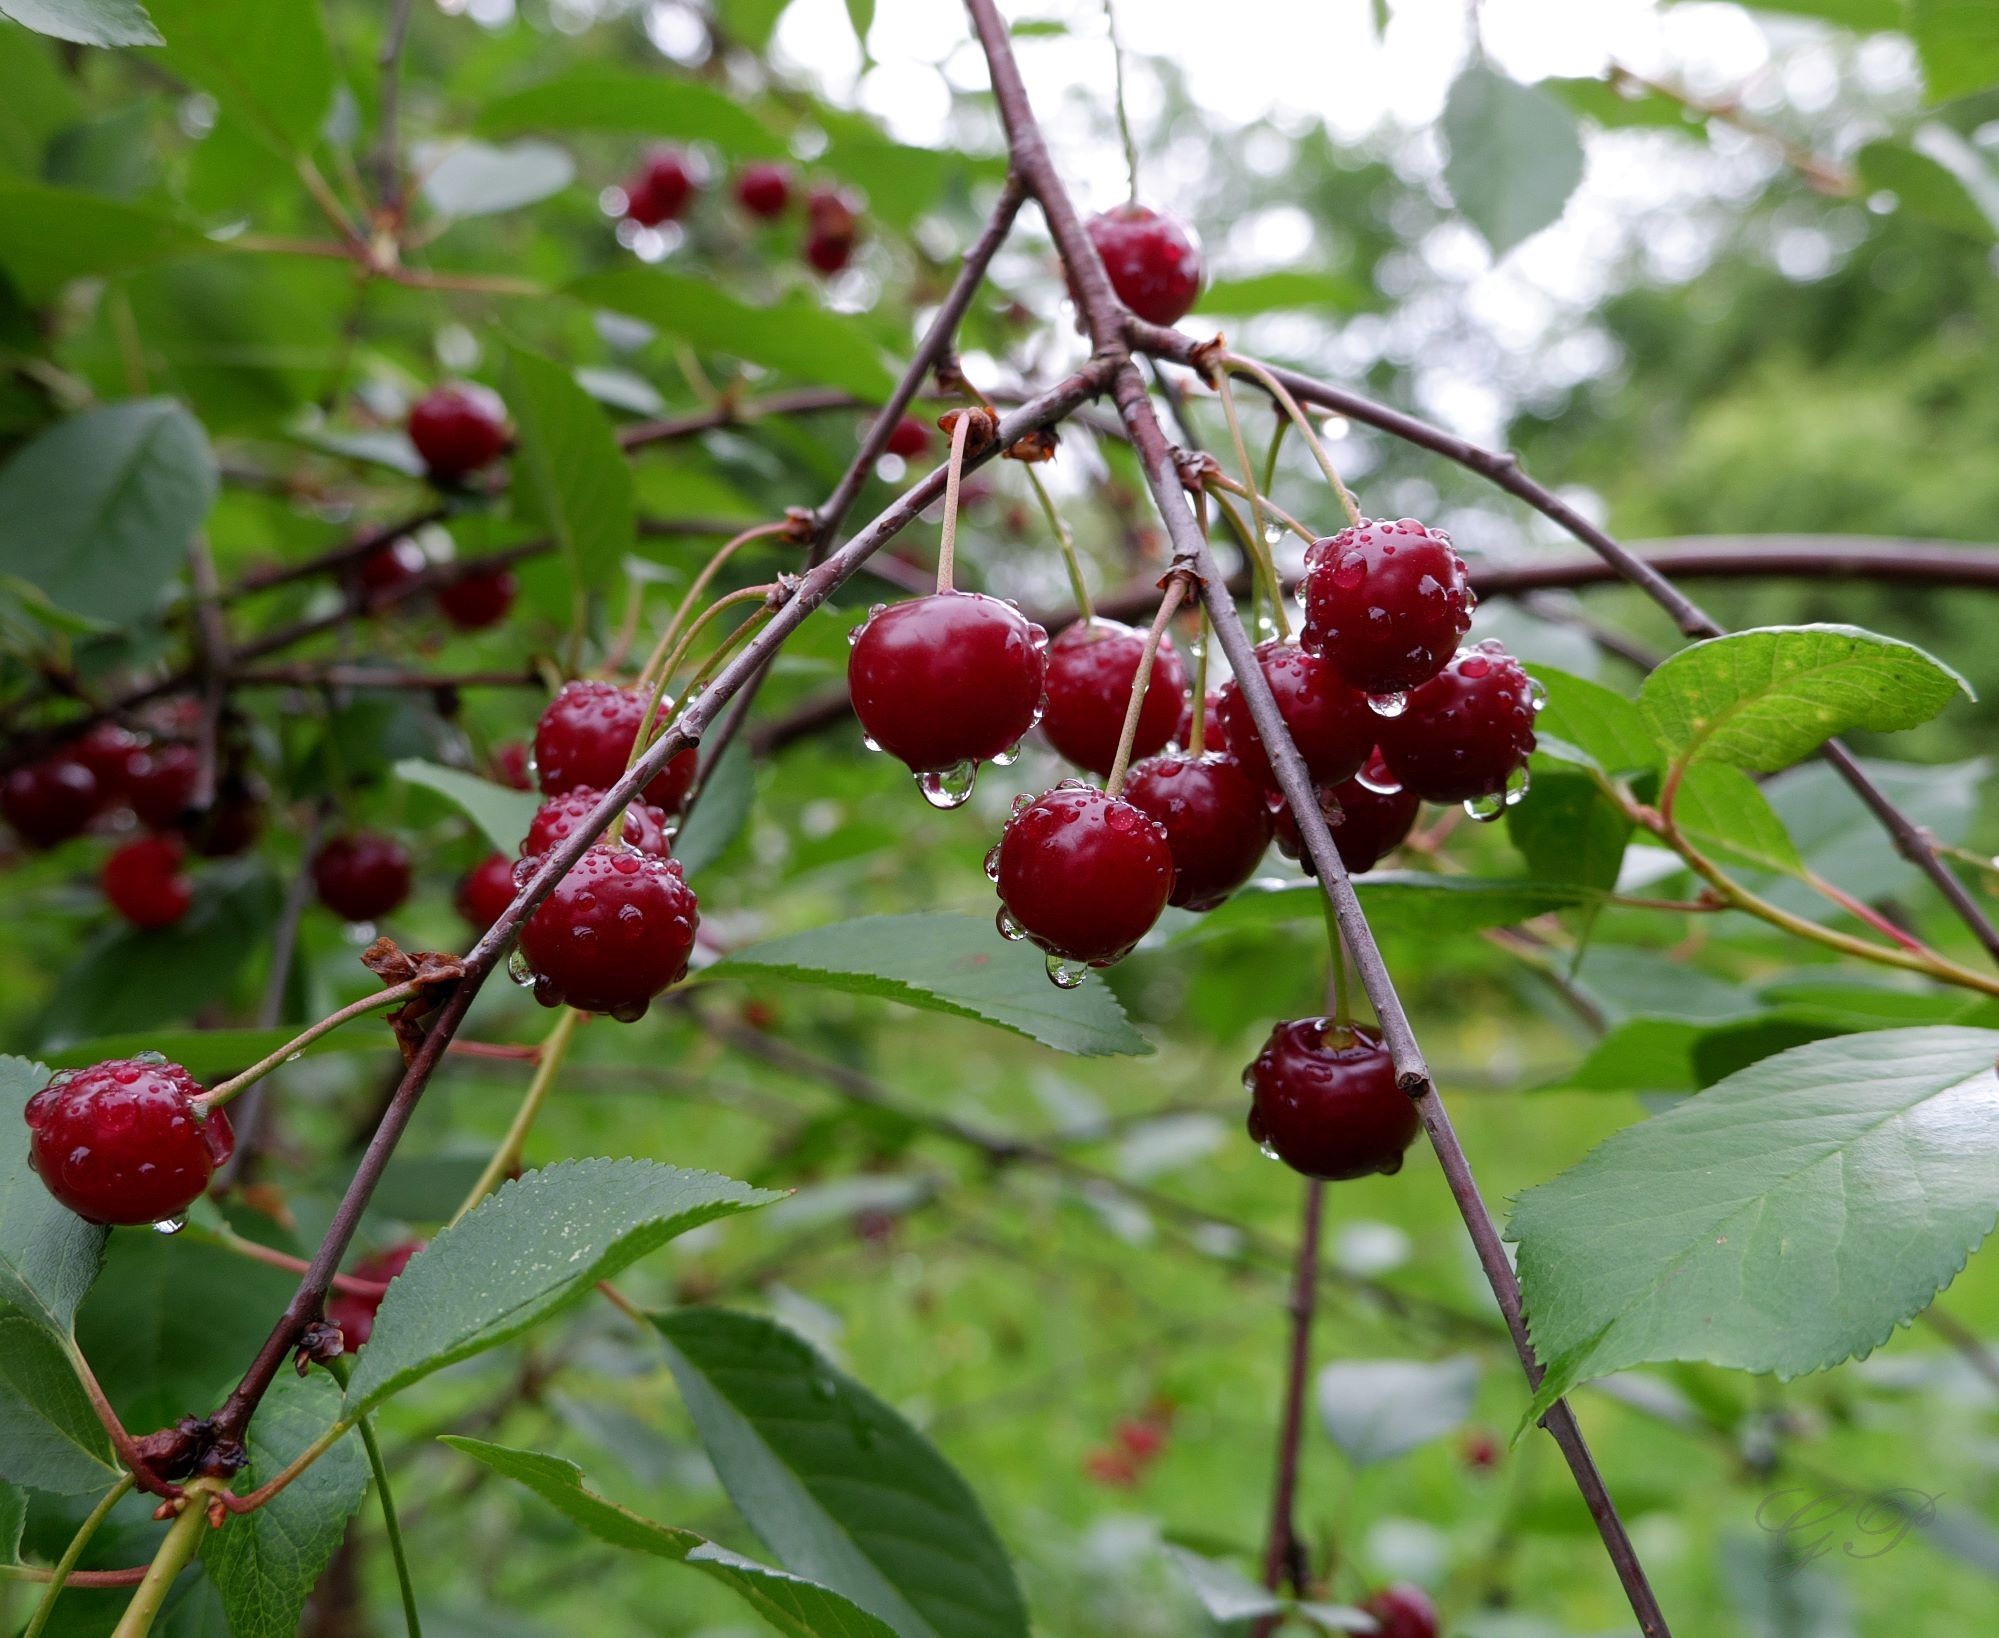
848, 592, 1047, 774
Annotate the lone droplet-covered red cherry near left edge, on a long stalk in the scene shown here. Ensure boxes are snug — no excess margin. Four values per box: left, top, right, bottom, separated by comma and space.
24, 1054, 236, 1226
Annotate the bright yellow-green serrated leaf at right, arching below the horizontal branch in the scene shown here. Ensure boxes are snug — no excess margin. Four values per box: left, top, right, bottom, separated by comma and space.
1637, 626, 1975, 774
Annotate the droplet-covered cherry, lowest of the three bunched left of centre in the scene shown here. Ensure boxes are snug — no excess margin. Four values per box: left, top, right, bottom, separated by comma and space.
516, 844, 702, 1024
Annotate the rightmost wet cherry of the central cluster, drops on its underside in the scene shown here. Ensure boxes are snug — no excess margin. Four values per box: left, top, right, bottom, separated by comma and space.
1379, 638, 1541, 802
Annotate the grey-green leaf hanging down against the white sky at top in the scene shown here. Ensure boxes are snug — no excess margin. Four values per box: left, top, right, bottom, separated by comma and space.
1443, 64, 1583, 256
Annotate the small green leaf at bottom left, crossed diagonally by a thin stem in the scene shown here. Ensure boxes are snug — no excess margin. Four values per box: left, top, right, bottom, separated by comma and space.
202, 1370, 368, 1638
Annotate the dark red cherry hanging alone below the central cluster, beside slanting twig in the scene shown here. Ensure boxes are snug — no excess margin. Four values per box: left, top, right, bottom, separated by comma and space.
1243, 1018, 1419, 1182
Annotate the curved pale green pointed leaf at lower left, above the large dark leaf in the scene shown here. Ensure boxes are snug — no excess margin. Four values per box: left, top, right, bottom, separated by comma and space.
346, 1160, 782, 1416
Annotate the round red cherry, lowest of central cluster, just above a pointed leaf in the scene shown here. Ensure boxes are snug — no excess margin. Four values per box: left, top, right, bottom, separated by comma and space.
990, 780, 1173, 966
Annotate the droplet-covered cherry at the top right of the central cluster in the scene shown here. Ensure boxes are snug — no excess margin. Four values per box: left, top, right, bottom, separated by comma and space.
1299, 518, 1477, 696
